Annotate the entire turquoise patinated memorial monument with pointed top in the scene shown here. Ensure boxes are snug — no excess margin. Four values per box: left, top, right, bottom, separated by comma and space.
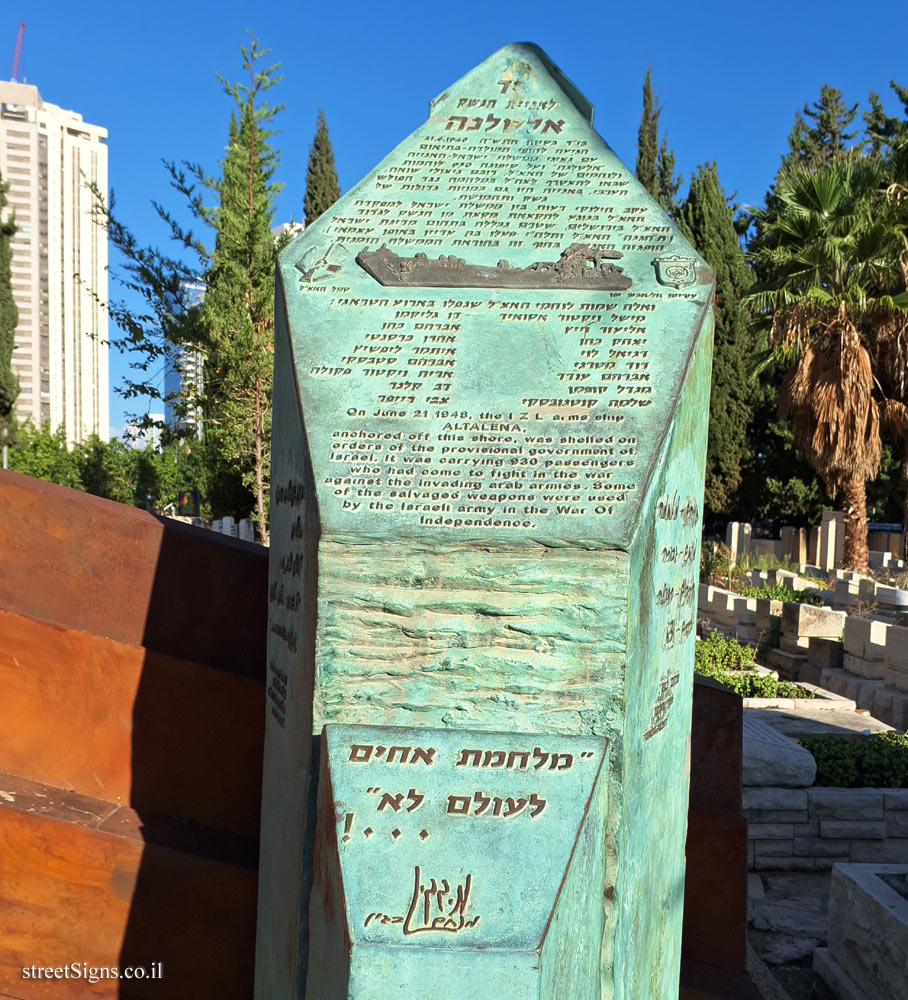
256, 44, 714, 1000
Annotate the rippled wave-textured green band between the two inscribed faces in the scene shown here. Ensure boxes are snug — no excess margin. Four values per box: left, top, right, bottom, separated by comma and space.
315, 541, 627, 735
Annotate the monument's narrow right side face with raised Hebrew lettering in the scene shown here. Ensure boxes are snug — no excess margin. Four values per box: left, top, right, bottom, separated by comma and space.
603, 312, 712, 1000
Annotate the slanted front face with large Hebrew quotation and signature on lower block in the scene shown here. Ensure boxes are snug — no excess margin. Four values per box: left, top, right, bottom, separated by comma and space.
324, 725, 606, 941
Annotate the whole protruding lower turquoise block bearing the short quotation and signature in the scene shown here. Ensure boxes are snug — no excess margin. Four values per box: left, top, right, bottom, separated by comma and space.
307, 726, 607, 1000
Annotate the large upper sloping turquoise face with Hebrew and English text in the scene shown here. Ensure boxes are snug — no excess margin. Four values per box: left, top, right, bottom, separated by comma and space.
291, 62, 708, 537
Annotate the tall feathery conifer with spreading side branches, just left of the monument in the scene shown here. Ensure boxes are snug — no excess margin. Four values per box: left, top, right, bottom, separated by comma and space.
96, 39, 282, 541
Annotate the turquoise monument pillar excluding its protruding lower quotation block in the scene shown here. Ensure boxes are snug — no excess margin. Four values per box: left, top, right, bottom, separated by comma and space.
256, 45, 714, 1000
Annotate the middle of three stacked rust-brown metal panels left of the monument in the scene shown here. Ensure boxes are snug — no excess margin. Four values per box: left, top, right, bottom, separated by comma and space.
0, 610, 265, 837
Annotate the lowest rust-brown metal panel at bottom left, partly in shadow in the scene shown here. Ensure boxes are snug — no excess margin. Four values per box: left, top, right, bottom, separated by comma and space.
0, 790, 256, 1000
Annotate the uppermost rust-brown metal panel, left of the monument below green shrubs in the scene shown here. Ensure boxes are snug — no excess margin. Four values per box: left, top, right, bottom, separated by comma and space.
0, 471, 268, 676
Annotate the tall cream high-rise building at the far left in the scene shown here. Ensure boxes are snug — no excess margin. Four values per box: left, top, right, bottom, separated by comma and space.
0, 81, 110, 442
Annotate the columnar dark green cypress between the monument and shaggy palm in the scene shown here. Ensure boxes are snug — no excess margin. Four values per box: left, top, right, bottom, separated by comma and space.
678, 163, 753, 514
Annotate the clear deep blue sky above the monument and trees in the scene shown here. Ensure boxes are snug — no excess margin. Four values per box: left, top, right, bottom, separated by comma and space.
10, 0, 908, 432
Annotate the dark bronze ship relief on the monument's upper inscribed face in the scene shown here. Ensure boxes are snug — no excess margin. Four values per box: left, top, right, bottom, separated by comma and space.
356, 243, 631, 291
